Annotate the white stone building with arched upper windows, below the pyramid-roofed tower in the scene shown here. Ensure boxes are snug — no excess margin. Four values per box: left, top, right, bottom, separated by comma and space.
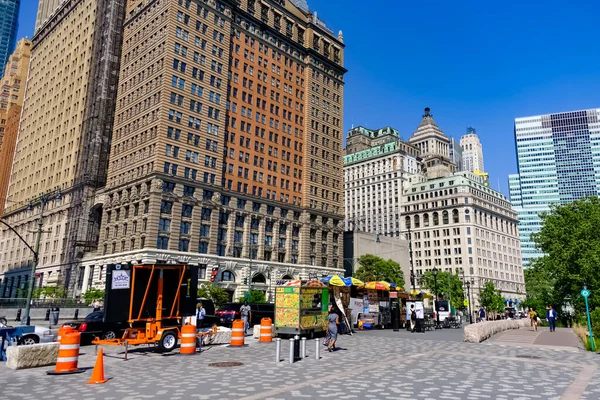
402, 172, 525, 307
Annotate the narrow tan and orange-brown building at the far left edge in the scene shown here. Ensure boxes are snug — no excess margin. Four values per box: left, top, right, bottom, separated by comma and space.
0, 39, 31, 216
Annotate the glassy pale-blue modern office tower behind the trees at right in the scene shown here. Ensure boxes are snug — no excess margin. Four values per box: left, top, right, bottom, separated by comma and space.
509, 108, 600, 266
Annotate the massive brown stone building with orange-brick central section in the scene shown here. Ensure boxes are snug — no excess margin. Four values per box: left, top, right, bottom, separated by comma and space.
83, 0, 346, 297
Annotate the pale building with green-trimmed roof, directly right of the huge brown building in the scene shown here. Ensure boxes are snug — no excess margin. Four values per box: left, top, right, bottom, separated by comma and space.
344, 127, 424, 237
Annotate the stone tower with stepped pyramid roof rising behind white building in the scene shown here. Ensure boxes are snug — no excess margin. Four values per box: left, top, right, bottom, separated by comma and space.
408, 107, 456, 179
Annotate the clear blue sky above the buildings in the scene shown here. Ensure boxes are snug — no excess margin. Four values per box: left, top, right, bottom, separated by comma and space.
19, 0, 600, 194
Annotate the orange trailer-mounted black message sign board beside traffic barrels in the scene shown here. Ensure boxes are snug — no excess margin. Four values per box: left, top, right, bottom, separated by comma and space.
92, 265, 216, 352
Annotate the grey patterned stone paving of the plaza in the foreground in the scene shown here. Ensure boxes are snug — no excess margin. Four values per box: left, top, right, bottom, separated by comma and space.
0, 330, 600, 400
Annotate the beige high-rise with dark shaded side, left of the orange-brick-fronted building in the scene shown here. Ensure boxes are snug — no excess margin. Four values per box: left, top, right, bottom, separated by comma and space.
0, 0, 124, 297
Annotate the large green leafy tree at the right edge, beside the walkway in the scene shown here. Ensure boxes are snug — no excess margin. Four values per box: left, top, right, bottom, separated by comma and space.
528, 196, 600, 313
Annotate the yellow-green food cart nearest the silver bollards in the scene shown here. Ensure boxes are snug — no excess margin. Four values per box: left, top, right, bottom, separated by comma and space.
275, 280, 329, 337
